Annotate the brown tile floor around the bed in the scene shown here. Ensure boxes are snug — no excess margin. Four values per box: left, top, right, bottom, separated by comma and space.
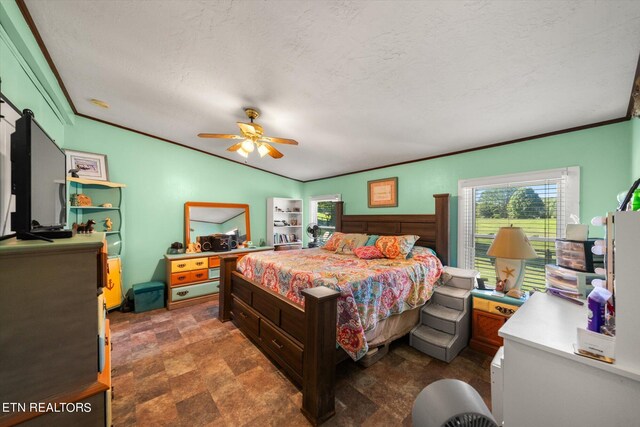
109, 302, 491, 427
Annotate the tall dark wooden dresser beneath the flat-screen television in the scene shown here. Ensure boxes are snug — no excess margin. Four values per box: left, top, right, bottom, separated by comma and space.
0, 233, 111, 426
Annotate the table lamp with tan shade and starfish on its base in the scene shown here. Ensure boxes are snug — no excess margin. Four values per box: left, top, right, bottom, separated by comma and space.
487, 226, 538, 298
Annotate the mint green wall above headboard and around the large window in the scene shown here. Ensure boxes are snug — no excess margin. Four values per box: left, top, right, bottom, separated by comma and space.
304, 120, 638, 265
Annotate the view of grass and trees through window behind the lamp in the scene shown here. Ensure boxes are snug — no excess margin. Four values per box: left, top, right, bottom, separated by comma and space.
474, 184, 558, 290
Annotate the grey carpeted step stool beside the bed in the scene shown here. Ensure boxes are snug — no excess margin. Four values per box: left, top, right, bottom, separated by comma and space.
409, 267, 480, 363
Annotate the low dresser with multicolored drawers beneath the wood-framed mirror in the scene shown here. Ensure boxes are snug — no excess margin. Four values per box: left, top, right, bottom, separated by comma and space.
164, 246, 273, 310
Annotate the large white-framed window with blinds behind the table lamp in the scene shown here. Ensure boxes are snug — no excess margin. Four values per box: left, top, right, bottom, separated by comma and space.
458, 167, 579, 290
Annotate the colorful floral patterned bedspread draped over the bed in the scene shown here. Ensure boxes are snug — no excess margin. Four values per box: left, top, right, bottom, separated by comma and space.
237, 247, 442, 360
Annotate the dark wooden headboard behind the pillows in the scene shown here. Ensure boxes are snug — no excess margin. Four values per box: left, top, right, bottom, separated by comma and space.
336, 194, 449, 265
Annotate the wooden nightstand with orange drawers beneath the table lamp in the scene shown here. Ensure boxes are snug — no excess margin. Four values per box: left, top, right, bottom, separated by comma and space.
469, 289, 528, 355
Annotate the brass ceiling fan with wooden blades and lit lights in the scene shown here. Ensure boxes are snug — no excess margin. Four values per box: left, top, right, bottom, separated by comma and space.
198, 108, 298, 159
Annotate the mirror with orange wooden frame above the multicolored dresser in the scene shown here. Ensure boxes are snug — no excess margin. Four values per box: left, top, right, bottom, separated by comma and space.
184, 202, 251, 246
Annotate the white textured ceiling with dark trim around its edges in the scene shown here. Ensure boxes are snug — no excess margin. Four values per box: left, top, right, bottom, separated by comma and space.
26, 0, 640, 180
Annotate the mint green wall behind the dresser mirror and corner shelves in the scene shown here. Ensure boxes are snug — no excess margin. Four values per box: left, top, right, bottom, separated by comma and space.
65, 117, 302, 287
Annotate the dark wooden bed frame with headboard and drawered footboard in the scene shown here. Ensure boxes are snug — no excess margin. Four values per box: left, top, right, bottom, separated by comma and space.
218, 194, 449, 425
